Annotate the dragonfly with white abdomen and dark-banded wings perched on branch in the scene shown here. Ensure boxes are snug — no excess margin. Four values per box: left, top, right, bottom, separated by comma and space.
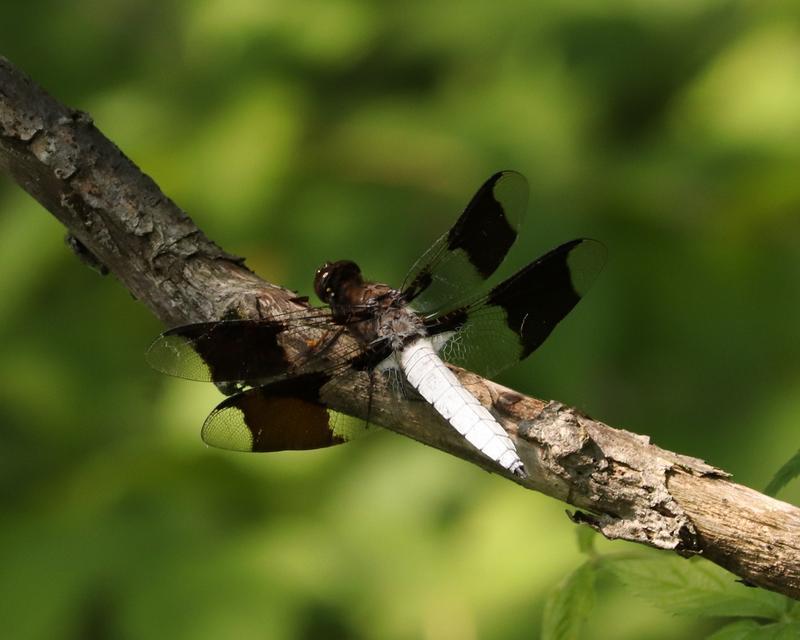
147, 171, 605, 477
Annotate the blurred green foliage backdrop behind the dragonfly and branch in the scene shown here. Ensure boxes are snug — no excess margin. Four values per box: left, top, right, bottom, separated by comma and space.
0, 0, 800, 640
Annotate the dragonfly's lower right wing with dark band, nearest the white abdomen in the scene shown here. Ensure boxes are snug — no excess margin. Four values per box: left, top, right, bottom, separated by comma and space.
428, 239, 606, 376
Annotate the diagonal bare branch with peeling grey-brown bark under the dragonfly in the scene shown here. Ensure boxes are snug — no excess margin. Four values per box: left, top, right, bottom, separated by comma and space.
0, 58, 800, 599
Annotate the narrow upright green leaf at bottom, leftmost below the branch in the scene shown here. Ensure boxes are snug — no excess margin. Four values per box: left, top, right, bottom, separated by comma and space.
542, 561, 596, 640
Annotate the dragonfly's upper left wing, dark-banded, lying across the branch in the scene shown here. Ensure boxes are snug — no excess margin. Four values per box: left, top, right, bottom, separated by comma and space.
146, 309, 346, 383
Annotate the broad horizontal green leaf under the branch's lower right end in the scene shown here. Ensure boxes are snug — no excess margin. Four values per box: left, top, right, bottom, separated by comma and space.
604, 556, 792, 620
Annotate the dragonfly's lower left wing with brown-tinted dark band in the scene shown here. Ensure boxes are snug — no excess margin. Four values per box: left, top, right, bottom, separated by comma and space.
202, 373, 366, 451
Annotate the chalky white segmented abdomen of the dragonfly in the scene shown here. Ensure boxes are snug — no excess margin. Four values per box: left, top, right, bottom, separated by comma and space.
397, 338, 527, 477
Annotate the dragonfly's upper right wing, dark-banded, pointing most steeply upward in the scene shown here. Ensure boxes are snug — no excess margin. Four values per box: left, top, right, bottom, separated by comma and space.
402, 171, 528, 314
